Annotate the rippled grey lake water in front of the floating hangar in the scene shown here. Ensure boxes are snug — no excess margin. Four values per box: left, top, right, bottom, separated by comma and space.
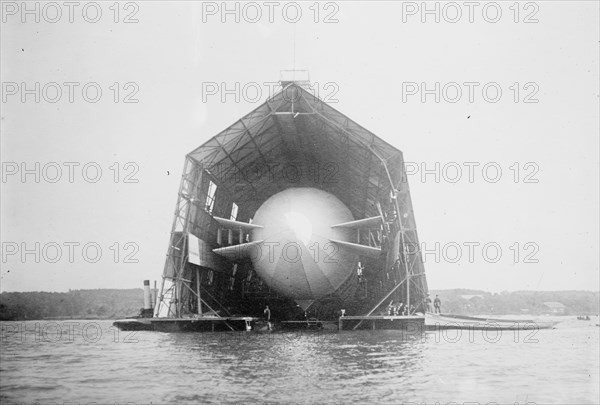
0, 317, 600, 405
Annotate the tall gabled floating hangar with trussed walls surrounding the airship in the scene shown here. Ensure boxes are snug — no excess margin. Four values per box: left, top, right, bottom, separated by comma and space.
155, 81, 427, 317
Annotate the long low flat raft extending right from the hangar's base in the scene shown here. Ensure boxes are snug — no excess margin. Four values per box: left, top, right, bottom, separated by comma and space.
425, 313, 558, 330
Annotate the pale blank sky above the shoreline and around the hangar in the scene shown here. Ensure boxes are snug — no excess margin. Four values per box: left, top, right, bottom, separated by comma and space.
1, 1, 600, 291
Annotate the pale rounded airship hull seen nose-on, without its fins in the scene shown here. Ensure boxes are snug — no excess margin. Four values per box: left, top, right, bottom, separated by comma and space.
252, 188, 357, 303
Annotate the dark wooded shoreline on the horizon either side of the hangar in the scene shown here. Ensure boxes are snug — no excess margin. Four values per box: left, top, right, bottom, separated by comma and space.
0, 288, 599, 320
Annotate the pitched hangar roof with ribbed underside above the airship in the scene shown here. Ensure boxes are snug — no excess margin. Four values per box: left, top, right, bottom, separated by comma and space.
188, 82, 412, 219
